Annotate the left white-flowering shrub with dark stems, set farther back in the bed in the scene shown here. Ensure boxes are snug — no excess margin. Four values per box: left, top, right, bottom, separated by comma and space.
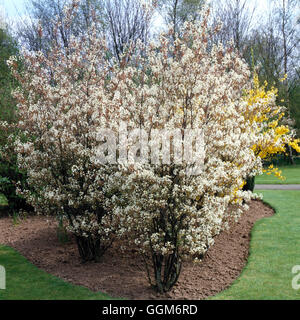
8, 2, 120, 261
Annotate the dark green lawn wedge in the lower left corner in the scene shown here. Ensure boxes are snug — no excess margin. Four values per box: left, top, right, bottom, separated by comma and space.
0, 246, 116, 300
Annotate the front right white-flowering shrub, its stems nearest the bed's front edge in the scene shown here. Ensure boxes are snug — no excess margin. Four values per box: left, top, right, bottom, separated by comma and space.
103, 10, 261, 292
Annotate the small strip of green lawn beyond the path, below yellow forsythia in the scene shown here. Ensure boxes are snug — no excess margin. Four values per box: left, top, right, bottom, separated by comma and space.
255, 164, 300, 184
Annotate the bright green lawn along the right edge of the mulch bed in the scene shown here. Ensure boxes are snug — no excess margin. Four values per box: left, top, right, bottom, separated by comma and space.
212, 190, 300, 300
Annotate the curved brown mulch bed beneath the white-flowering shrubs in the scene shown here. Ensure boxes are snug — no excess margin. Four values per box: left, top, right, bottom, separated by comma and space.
0, 200, 274, 300
